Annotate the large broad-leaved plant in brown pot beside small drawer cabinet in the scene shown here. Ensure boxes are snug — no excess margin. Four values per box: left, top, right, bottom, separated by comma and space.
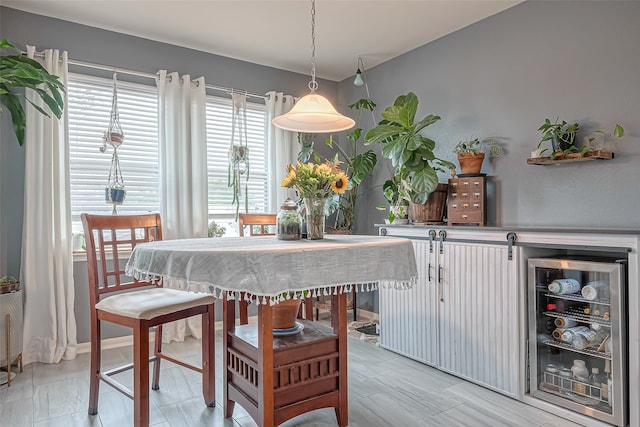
365, 92, 455, 222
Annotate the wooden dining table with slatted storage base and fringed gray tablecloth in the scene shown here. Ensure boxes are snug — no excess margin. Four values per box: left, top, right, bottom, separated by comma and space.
126, 235, 417, 427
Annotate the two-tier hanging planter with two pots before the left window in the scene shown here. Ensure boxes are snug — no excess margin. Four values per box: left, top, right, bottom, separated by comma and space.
100, 73, 127, 215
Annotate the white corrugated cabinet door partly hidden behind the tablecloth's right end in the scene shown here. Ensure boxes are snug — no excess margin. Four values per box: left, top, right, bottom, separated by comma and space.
379, 240, 438, 366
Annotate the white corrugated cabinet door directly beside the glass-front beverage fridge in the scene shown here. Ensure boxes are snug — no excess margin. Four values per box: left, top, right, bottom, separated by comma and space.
438, 241, 520, 397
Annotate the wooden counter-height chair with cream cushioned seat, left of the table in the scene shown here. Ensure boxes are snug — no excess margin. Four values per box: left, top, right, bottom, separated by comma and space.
82, 214, 215, 427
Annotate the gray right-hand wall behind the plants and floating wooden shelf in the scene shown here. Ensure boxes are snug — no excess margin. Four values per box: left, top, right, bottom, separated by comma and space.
339, 0, 640, 233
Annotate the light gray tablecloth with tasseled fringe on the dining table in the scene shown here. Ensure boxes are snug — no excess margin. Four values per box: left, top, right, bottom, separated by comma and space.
126, 235, 417, 303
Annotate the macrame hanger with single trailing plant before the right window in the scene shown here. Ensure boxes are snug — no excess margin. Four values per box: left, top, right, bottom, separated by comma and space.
228, 89, 249, 220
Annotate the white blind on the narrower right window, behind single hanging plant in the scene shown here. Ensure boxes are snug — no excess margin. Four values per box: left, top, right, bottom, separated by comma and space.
206, 96, 268, 219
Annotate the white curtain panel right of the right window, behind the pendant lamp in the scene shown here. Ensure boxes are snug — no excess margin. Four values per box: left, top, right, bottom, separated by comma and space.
265, 91, 300, 212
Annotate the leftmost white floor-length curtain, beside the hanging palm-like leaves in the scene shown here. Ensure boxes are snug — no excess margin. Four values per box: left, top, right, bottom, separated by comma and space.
20, 46, 77, 364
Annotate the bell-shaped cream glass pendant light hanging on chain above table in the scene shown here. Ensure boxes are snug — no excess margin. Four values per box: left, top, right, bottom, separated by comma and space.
271, 0, 356, 133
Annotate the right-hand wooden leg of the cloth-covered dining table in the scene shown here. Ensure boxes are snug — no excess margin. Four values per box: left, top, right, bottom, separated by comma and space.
331, 292, 349, 427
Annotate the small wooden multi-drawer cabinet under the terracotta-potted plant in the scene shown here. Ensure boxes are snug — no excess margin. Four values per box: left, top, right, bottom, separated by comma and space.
447, 176, 487, 226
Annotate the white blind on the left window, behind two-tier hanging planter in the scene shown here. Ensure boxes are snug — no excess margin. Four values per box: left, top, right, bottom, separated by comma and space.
67, 73, 160, 231
